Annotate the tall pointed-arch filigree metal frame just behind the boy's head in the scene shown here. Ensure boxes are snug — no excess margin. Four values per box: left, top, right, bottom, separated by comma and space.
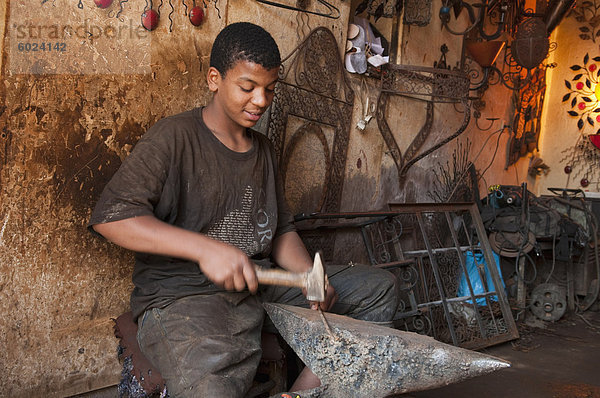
267, 27, 354, 259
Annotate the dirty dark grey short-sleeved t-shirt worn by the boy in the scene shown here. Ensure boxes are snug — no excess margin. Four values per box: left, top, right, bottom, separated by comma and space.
89, 108, 294, 319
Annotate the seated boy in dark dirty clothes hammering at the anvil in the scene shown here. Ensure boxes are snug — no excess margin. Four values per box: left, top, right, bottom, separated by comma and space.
89, 23, 397, 398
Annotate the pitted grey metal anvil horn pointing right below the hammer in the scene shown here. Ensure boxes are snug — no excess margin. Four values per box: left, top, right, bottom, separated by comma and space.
264, 303, 510, 398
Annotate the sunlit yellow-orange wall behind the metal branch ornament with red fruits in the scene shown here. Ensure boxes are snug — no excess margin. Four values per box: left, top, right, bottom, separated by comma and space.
539, 8, 600, 194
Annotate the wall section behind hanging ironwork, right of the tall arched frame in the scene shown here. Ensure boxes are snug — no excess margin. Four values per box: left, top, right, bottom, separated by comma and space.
343, 1, 535, 215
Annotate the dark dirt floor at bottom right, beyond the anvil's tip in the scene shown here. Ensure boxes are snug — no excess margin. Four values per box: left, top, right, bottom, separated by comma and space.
398, 311, 600, 398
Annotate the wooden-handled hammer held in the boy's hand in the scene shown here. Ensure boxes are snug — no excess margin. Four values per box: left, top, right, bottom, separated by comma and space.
254, 253, 327, 302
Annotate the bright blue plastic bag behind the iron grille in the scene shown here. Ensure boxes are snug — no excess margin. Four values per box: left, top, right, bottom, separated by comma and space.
457, 251, 505, 305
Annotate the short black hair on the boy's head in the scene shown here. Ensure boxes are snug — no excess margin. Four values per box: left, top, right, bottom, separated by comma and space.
210, 22, 281, 77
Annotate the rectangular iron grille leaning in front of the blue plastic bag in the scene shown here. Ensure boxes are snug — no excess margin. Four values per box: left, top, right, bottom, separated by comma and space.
390, 204, 518, 349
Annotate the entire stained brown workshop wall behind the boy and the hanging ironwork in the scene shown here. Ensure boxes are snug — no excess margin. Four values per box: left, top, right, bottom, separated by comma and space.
0, 0, 535, 397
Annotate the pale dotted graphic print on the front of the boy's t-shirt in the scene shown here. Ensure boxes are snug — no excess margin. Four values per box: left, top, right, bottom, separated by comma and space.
206, 185, 273, 256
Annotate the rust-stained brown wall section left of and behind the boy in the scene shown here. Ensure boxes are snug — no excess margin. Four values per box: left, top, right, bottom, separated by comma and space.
0, 0, 348, 397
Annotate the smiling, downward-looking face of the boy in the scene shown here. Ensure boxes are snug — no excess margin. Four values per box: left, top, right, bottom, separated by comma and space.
209, 61, 279, 127
